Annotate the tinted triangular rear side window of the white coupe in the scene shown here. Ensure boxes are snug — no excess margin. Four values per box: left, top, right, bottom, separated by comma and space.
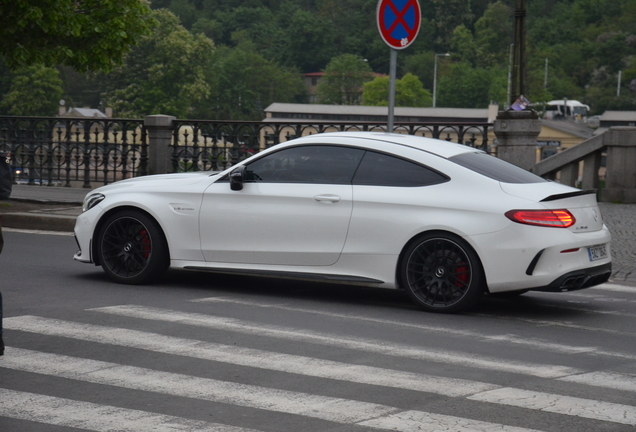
353, 151, 450, 187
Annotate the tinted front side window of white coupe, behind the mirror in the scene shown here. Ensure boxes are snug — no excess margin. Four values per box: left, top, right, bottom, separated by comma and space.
245, 145, 364, 184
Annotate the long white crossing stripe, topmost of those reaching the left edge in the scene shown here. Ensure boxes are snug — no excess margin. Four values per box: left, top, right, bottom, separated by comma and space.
5, 316, 498, 397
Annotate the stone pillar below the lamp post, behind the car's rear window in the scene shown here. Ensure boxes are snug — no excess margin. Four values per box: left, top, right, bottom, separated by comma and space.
494, 110, 541, 170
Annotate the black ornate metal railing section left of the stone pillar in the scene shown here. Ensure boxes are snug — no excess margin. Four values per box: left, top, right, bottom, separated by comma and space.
0, 116, 148, 188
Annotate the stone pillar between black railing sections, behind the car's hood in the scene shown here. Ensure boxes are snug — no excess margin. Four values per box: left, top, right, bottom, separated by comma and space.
144, 114, 176, 174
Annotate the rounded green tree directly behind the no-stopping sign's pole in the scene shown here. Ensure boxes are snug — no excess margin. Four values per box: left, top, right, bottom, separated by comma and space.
362, 73, 433, 107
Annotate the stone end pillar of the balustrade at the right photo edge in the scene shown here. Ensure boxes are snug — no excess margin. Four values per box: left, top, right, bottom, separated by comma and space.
601, 126, 636, 203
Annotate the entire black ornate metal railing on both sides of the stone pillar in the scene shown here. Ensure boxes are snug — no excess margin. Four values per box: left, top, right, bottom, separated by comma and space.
0, 116, 492, 188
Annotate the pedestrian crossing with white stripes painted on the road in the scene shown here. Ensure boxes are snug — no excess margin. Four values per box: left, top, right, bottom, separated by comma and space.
0, 286, 636, 432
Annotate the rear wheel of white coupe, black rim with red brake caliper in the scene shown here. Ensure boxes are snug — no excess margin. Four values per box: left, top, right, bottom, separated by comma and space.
400, 233, 485, 313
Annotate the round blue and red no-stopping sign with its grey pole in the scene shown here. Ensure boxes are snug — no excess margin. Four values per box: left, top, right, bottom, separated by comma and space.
376, 0, 422, 132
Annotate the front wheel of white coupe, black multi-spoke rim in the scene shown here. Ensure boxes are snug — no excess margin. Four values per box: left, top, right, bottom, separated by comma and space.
97, 209, 170, 284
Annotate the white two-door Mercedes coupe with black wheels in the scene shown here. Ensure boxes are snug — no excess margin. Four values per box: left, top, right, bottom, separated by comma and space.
74, 132, 611, 312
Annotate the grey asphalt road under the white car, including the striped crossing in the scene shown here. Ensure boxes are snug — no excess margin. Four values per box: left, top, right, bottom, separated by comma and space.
0, 230, 636, 432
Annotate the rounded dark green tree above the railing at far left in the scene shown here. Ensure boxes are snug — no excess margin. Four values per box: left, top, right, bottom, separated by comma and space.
0, 64, 64, 116
